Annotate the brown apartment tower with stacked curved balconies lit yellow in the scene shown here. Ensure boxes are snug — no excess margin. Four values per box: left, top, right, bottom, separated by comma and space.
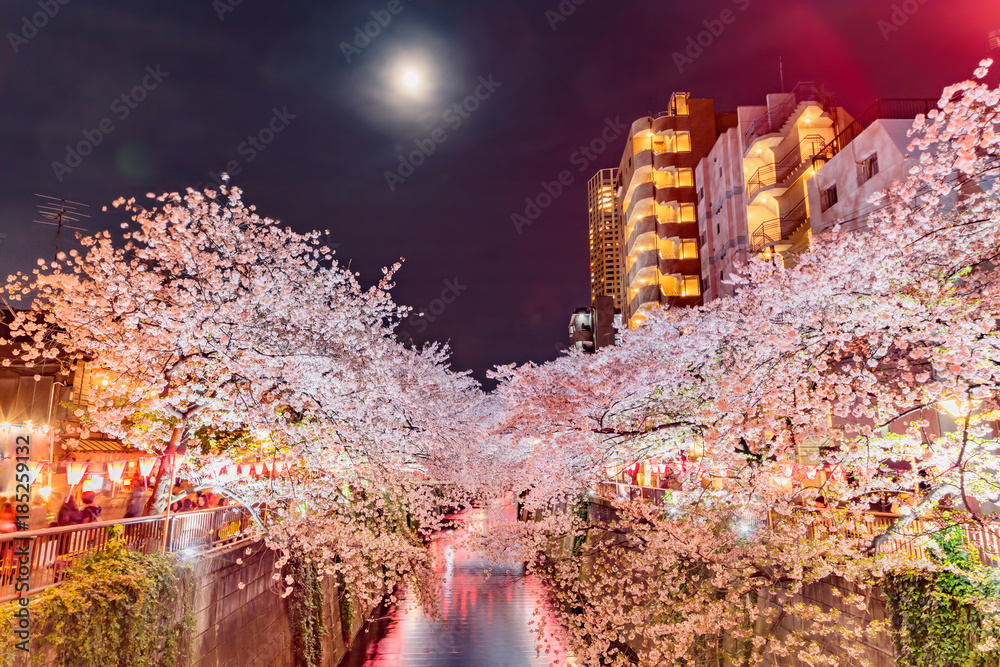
615, 93, 736, 328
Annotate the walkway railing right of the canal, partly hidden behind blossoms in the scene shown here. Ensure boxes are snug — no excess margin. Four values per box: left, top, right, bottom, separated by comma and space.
597, 482, 1000, 567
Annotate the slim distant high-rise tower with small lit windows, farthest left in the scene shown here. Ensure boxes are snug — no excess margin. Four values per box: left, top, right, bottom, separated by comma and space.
587, 169, 622, 309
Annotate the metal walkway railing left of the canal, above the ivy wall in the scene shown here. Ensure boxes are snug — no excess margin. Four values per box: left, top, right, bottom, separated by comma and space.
0, 505, 255, 602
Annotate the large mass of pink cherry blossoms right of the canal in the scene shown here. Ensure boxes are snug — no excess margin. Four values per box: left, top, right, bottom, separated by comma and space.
472, 62, 1000, 665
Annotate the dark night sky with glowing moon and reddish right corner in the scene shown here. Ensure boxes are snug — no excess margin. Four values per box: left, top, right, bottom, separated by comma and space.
0, 0, 1000, 378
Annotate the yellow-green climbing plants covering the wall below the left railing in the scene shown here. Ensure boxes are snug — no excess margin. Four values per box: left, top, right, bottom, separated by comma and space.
0, 526, 194, 667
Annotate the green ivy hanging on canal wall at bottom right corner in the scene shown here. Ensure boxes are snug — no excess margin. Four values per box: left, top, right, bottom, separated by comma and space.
882, 529, 1000, 667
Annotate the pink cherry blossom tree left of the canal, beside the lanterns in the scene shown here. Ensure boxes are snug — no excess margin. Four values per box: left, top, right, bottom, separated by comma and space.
0, 186, 481, 602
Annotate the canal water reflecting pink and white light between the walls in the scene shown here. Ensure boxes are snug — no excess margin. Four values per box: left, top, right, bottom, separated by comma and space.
341, 507, 577, 667
